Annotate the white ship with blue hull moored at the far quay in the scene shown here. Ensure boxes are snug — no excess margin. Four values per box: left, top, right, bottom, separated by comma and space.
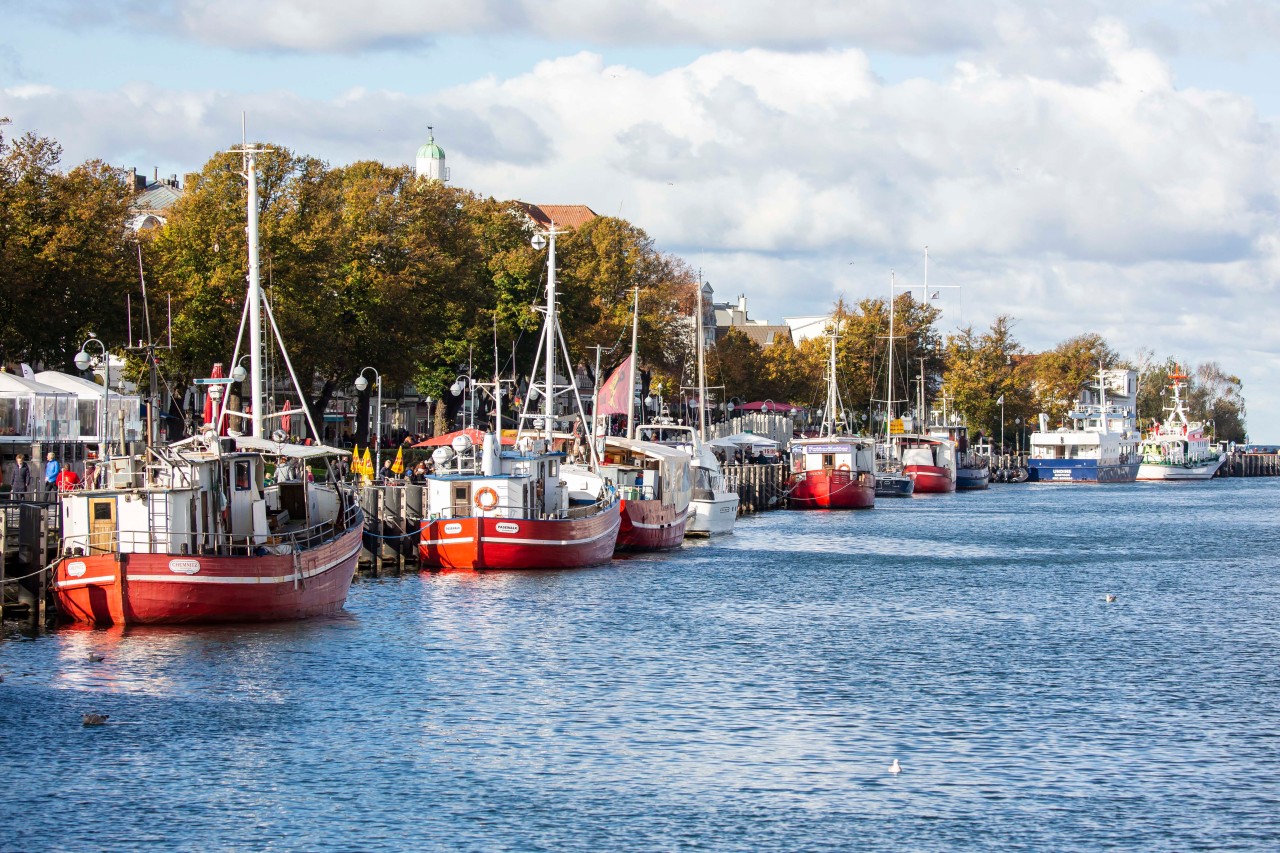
1027, 368, 1142, 483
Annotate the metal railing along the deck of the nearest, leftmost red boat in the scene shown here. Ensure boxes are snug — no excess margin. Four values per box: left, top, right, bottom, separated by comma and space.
59, 501, 365, 557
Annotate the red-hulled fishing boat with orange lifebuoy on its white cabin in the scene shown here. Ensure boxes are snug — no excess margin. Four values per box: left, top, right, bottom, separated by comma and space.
419, 222, 622, 570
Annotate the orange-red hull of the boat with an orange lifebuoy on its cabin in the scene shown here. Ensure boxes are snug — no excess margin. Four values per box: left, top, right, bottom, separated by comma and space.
419, 503, 621, 570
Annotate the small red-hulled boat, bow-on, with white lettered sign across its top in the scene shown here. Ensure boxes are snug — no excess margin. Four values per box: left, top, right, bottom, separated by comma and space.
788, 320, 876, 510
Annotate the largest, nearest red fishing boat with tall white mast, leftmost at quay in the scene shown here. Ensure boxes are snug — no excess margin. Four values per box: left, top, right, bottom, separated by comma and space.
54, 140, 364, 625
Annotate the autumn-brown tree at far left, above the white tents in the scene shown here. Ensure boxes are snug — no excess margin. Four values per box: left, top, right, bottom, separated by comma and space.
0, 133, 138, 369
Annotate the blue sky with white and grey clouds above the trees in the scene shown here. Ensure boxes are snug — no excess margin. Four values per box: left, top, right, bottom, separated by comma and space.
0, 0, 1280, 442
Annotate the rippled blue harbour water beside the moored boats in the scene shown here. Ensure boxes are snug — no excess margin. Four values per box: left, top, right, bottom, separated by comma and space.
0, 480, 1280, 850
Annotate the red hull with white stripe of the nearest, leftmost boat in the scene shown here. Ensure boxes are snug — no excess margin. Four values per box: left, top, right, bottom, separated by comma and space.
54, 526, 361, 625
